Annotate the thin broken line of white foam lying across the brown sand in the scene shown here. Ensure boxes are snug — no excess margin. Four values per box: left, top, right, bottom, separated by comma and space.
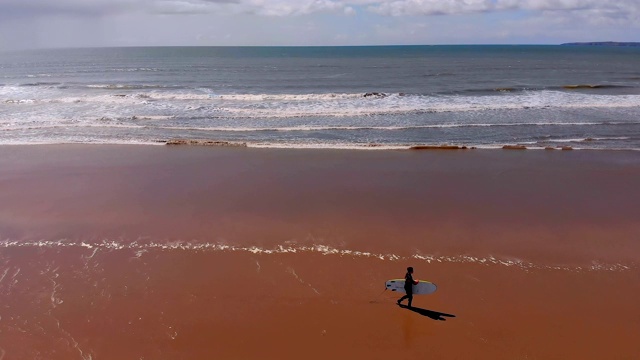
0, 240, 635, 272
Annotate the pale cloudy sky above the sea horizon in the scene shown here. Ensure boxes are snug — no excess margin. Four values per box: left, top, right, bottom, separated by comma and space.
0, 0, 640, 50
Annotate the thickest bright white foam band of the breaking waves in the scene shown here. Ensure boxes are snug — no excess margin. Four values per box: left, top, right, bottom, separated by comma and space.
5, 89, 640, 118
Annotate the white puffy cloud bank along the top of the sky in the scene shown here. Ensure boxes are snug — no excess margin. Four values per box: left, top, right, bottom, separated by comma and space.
0, 0, 640, 21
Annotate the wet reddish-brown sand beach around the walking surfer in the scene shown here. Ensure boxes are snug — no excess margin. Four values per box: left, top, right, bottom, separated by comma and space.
0, 145, 640, 359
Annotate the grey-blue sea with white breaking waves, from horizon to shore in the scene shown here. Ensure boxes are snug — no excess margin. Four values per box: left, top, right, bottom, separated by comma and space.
0, 45, 640, 150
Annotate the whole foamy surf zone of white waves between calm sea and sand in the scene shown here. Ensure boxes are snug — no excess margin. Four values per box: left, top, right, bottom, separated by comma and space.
5, 84, 640, 150
